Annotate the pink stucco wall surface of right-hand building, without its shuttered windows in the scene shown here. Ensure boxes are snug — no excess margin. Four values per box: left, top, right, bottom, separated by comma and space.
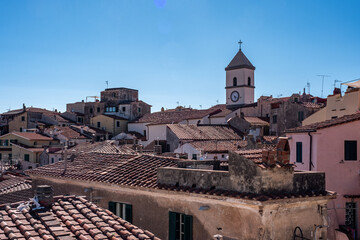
287, 121, 360, 237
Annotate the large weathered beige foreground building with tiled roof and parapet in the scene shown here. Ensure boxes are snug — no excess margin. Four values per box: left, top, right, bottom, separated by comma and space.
27, 143, 334, 240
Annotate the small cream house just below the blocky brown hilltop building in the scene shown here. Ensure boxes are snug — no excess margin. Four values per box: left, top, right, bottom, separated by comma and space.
90, 115, 128, 137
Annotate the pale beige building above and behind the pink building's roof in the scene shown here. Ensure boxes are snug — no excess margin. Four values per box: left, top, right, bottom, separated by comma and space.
302, 82, 360, 126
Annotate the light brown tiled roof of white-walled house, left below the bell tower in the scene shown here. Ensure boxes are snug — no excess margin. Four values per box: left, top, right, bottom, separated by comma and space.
167, 124, 241, 140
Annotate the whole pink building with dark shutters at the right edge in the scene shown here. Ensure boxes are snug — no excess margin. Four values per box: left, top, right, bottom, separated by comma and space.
286, 113, 360, 239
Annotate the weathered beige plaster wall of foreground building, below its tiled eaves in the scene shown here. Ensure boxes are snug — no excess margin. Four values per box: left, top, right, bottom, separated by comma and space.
32, 176, 327, 240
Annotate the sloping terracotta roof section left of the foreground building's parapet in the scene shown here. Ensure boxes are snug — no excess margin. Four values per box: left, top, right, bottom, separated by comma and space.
27, 153, 178, 188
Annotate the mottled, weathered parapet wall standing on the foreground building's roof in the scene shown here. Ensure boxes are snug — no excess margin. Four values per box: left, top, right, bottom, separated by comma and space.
157, 153, 325, 194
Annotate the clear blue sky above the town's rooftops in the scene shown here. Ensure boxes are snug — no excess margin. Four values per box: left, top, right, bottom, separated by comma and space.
0, 0, 360, 112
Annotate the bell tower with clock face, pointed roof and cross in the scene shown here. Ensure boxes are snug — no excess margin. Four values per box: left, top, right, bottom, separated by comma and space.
225, 41, 255, 109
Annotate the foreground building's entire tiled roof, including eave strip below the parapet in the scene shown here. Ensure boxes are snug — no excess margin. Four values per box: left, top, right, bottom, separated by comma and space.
27, 150, 334, 201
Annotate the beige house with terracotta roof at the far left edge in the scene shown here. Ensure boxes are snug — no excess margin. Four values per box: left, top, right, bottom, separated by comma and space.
0, 132, 58, 169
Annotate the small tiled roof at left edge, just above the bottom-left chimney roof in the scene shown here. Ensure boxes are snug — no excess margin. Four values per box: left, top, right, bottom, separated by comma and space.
0, 174, 33, 204
